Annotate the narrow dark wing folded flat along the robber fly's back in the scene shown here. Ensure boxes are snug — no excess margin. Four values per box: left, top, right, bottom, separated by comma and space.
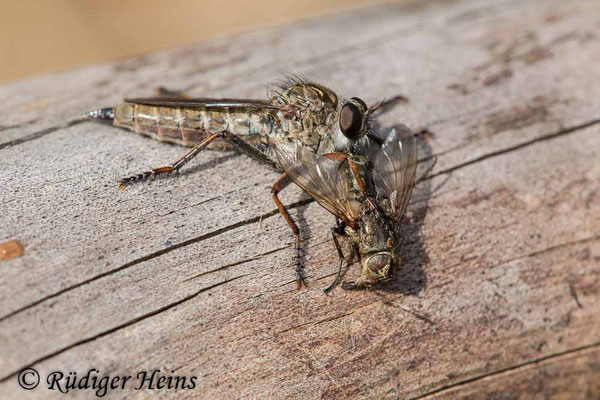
125, 97, 280, 110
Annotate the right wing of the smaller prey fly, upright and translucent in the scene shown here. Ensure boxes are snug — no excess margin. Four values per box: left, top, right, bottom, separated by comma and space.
373, 125, 417, 219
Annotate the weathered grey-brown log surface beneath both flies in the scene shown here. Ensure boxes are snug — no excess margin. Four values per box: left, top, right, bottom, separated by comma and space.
0, 0, 600, 399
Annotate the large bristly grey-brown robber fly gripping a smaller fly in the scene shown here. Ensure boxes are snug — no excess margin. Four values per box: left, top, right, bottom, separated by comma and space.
82, 76, 390, 284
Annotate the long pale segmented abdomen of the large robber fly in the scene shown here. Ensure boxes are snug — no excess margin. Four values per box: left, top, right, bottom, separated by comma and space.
113, 103, 273, 150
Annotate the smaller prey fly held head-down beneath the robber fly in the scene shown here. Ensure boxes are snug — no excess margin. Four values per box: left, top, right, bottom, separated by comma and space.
275, 125, 417, 292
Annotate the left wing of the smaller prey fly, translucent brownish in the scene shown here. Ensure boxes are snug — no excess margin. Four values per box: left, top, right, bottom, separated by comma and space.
275, 143, 362, 224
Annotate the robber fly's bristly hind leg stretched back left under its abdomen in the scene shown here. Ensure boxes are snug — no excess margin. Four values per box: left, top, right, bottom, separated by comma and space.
117, 131, 277, 190
